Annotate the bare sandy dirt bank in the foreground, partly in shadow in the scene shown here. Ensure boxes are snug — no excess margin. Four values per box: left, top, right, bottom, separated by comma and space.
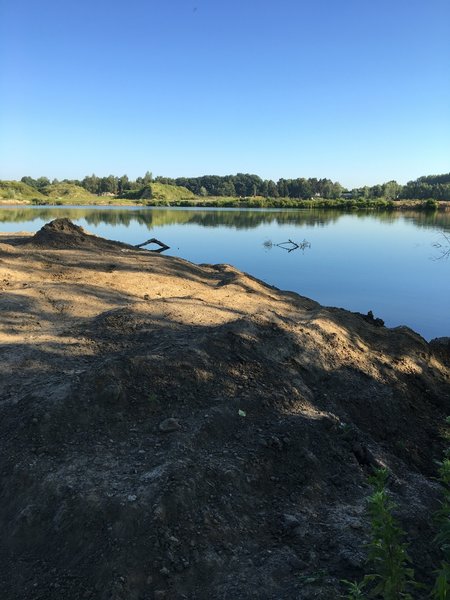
0, 225, 450, 600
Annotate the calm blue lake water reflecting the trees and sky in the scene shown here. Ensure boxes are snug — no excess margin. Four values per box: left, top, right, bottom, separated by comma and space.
0, 207, 450, 339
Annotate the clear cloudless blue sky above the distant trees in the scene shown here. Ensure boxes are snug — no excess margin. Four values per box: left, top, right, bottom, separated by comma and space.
0, 0, 450, 187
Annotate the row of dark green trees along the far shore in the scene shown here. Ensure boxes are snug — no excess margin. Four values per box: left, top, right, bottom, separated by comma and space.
21, 171, 450, 200
